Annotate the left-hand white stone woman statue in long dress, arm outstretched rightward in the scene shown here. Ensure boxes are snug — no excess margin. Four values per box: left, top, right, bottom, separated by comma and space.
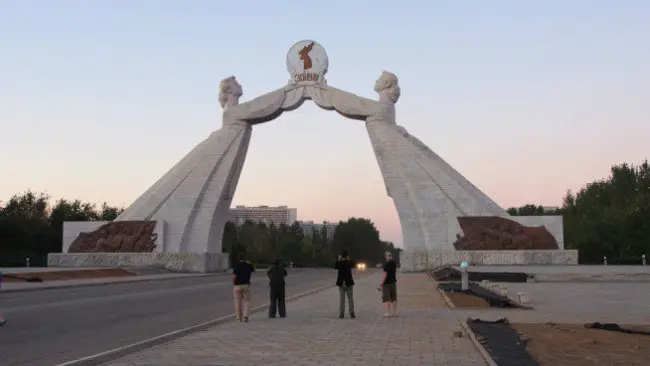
117, 76, 285, 253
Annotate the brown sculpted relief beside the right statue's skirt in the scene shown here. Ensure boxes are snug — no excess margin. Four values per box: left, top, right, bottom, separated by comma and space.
454, 216, 559, 250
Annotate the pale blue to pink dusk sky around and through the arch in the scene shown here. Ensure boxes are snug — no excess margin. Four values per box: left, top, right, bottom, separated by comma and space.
0, 0, 650, 245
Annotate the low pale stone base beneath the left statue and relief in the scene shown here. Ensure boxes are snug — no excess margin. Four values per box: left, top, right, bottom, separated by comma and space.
47, 253, 229, 273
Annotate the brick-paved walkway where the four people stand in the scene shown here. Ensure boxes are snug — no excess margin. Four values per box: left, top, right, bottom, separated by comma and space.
106, 273, 485, 366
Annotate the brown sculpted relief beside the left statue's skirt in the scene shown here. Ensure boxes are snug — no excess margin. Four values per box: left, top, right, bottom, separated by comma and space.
68, 221, 158, 253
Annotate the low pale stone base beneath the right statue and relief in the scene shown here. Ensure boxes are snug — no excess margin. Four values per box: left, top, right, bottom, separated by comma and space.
400, 250, 578, 272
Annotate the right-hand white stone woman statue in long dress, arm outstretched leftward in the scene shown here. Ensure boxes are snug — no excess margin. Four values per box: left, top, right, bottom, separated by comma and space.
329, 71, 505, 254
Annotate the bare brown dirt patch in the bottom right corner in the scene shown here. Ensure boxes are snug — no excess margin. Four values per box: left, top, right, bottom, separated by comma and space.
511, 323, 650, 366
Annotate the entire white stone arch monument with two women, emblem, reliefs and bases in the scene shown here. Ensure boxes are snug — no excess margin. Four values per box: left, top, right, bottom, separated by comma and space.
48, 40, 577, 272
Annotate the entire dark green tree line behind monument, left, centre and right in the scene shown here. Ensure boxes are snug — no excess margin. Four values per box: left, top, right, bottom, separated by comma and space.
0, 160, 650, 267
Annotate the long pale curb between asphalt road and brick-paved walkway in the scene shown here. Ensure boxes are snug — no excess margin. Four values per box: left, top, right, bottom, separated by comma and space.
56, 276, 365, 366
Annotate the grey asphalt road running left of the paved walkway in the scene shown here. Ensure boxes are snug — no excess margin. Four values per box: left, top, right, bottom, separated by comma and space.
0, 269, 335, 366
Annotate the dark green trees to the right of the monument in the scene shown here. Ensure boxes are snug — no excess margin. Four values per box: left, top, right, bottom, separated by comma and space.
508, 160, 650, 264
